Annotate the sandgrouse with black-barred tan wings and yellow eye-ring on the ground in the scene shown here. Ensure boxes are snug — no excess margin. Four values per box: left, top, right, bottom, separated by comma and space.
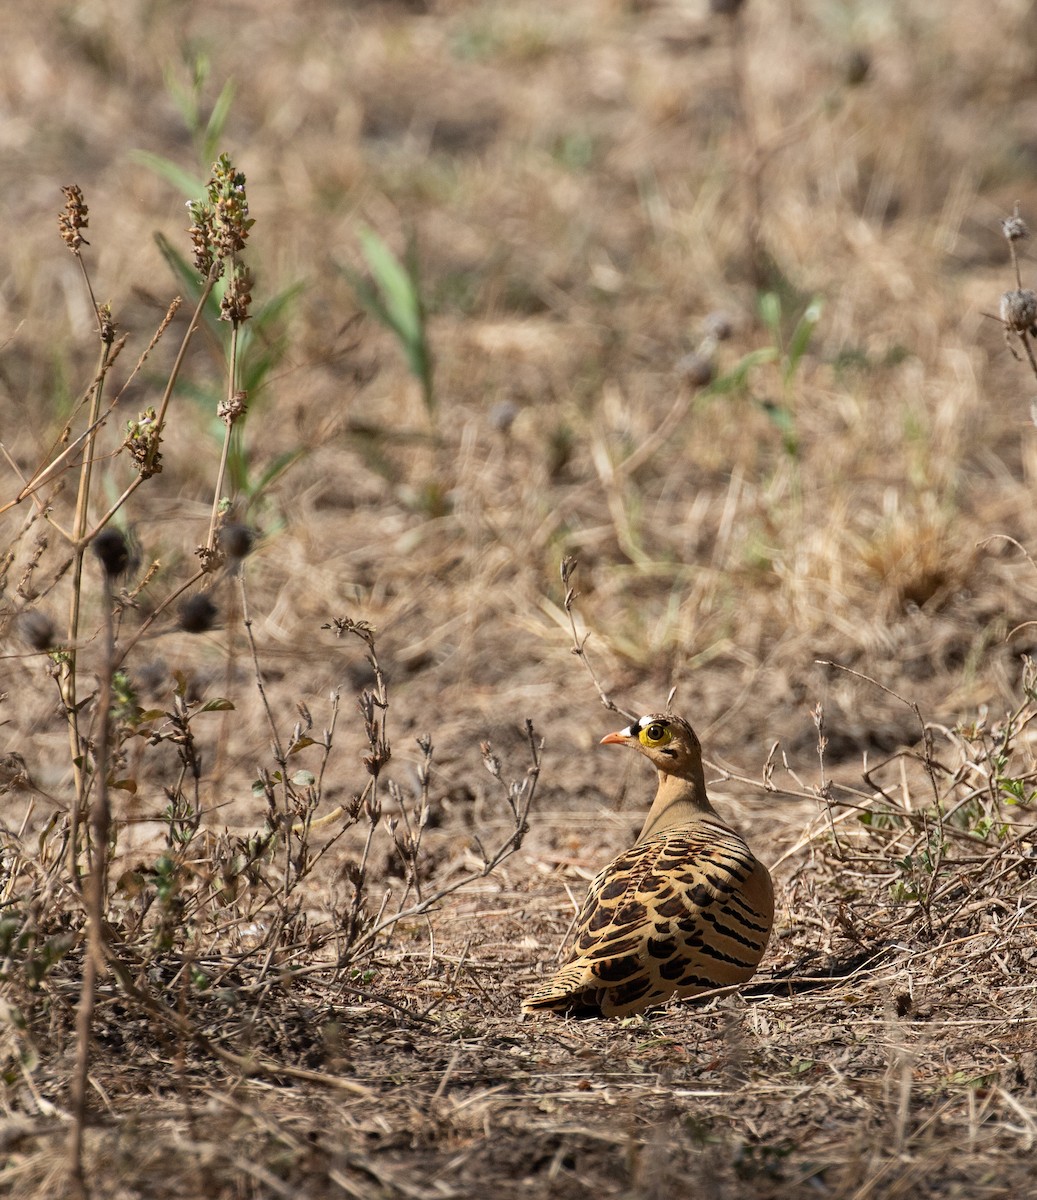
522, 713, 774, 1019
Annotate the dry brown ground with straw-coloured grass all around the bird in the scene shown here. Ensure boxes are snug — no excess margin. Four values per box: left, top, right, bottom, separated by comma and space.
0, 0, 1037, 1200
